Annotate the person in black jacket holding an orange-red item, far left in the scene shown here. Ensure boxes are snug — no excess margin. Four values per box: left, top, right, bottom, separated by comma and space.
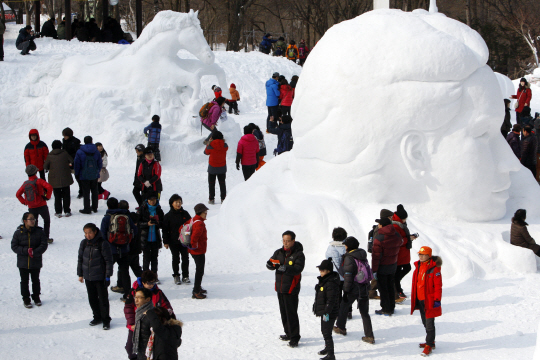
11, 212, 48, 309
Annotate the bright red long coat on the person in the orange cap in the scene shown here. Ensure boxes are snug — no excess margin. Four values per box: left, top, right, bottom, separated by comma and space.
411, 256, 442, 319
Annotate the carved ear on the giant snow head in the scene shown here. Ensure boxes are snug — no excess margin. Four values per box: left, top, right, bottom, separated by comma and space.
400, 131, 429, 180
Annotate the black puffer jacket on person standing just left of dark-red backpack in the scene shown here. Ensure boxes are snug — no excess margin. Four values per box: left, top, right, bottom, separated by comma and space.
77, 230, 114, 281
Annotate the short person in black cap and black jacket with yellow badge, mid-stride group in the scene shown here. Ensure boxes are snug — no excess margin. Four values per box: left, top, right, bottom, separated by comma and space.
313, 260, 340, 360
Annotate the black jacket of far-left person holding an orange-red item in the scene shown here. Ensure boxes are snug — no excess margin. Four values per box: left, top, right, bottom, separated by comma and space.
11, 225, 49, 269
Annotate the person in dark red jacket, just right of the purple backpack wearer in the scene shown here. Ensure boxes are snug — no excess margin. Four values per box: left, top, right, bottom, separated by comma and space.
371, 218, 403, 316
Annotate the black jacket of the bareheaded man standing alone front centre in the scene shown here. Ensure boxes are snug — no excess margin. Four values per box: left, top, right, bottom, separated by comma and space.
266, 241, 306, 294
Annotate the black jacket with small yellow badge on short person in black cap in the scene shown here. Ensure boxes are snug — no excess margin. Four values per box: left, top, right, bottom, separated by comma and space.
313, 271, 340, 317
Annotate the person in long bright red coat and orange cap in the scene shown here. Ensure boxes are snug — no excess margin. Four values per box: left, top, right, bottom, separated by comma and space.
411, 246, 442, 356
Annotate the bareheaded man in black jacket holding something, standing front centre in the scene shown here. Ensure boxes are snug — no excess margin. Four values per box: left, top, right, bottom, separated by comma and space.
266, 230, 306, 348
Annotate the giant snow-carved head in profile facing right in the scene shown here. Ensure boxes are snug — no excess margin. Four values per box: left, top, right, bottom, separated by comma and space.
290, 10, 519, 221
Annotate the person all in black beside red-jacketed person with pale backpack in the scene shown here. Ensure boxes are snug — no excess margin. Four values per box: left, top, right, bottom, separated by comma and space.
162, 194, 191, 285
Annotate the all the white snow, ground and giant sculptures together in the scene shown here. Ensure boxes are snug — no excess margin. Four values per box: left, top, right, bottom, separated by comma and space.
0, 10, 540, 360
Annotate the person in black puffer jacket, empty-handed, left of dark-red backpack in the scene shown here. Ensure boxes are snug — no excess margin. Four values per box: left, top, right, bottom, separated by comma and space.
77, 223, 114, 330
